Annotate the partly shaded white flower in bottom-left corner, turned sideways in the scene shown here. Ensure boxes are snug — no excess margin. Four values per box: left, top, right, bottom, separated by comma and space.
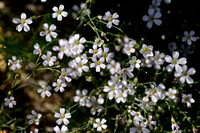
26, 110, 42, 125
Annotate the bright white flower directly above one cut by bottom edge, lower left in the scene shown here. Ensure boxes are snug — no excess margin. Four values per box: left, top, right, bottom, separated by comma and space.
54, 108, 71, 125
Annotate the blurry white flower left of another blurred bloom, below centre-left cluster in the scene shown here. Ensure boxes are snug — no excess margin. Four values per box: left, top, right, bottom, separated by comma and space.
73, 89, 88, 106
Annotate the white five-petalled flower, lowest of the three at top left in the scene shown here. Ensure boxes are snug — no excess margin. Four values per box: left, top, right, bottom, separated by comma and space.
40, 23, 58, 42
